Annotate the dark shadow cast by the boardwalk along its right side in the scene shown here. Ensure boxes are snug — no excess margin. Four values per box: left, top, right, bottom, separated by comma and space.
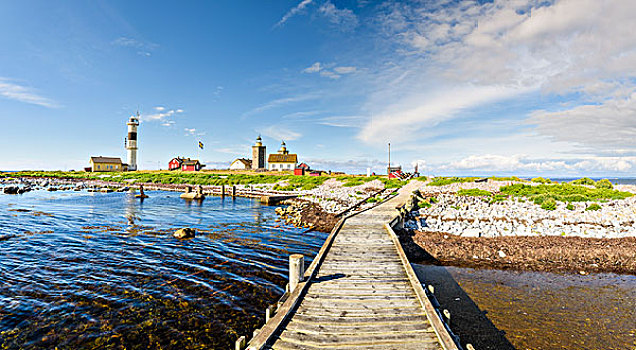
398, 232, 515, 350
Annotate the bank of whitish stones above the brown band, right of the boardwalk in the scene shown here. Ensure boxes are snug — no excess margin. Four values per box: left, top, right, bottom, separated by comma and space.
413, 183, 636, 238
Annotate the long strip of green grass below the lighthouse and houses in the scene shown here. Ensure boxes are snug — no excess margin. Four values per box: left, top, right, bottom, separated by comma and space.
0, 171, 406, 191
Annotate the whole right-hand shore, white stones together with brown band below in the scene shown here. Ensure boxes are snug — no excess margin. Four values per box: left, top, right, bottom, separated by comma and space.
399, 181, 636, 275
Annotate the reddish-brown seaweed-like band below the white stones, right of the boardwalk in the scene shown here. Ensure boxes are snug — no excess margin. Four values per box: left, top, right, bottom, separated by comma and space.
399, 230, 636, 275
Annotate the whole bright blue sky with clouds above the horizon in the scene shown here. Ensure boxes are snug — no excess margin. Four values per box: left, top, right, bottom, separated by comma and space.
0, 0, 636, 176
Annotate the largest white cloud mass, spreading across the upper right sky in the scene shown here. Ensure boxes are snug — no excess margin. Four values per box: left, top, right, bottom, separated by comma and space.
358, 0, 636, 160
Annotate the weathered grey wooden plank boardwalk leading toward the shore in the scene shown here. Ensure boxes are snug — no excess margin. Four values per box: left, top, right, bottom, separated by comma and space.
249, 185, 457, 350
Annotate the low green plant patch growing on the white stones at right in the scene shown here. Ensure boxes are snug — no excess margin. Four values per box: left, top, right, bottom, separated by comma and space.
500, 183, 632, 204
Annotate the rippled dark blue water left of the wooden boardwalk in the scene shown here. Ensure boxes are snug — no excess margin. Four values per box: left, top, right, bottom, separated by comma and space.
0, 191, 326, 349
